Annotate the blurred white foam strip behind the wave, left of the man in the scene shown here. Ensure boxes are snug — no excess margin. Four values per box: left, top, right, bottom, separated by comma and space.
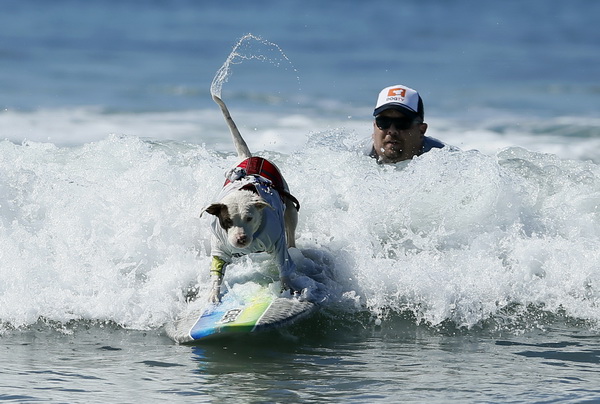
0, 105, 369, 152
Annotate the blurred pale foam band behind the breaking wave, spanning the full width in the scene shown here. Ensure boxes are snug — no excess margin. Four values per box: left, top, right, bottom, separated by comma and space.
0, 109, 600, 163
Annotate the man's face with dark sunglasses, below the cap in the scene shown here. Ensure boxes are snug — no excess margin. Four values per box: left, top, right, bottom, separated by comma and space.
373, 109, 427, 163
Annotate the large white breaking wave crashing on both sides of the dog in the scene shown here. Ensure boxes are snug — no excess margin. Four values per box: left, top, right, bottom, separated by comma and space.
0, 111, 600, 329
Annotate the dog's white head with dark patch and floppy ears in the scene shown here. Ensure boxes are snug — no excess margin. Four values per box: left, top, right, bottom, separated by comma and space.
200, 190, 272, 248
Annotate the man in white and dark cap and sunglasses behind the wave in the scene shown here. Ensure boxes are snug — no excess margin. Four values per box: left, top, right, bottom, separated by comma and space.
369, 85, 445, 164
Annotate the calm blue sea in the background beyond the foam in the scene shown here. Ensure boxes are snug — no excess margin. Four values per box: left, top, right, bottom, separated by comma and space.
0, 0, 600, 117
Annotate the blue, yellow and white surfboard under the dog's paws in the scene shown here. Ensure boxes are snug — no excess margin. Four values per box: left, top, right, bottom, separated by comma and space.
166, 286, 316, 343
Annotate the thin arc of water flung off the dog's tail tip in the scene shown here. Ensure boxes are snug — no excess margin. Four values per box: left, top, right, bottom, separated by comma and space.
210, 33, 300, 98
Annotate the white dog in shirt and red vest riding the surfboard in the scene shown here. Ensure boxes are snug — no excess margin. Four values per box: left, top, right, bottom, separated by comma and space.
200, 95, 301, 303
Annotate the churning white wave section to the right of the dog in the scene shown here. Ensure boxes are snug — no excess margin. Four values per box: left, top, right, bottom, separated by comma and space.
290, 136, 600, 329
